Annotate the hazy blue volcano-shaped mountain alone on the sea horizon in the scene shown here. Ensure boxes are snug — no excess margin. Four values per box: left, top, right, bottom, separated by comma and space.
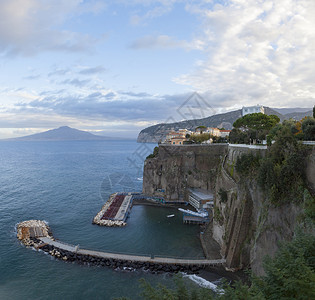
10, 126, 113, 141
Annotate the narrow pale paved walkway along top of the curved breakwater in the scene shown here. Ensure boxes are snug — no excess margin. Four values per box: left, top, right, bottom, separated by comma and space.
39, 237, 225, 266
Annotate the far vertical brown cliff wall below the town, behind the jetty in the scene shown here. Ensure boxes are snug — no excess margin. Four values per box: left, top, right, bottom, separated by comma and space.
143, 144, 227, 201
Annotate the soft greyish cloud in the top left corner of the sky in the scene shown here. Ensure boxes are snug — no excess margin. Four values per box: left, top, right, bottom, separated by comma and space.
0, 0, 106, 56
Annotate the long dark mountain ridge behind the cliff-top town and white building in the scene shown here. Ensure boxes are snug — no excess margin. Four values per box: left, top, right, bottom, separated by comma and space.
137, 107, 312, 143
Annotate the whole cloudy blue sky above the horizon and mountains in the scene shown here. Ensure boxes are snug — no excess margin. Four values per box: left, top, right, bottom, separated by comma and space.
0, 0, 315, 138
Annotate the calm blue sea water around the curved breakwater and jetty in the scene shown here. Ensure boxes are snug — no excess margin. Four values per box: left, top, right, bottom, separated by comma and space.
0, 141, 207, 299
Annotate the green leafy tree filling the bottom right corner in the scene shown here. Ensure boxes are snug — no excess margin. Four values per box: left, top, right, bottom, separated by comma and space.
253, 229, 315, 300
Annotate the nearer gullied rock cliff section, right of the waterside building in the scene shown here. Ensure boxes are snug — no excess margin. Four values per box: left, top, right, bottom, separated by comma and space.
212, 147, 315, 275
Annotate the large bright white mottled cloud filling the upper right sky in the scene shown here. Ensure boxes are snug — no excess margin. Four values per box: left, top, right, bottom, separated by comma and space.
174, 0, 315, 107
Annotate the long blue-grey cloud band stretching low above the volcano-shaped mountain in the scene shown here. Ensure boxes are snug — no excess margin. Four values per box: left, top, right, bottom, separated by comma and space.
9, 90, 218, 127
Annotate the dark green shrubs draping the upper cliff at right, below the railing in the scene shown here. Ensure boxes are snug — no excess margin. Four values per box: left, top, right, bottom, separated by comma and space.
235, 118, 314, 211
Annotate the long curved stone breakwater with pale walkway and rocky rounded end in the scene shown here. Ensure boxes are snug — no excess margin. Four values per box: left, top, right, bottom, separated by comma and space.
17, 220, 225, 274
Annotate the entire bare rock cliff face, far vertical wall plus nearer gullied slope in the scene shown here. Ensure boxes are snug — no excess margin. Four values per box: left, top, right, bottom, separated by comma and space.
143, 145, 315, 275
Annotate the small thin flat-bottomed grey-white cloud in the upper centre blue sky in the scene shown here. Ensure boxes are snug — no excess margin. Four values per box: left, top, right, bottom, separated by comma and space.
130, 35, 203, 50
